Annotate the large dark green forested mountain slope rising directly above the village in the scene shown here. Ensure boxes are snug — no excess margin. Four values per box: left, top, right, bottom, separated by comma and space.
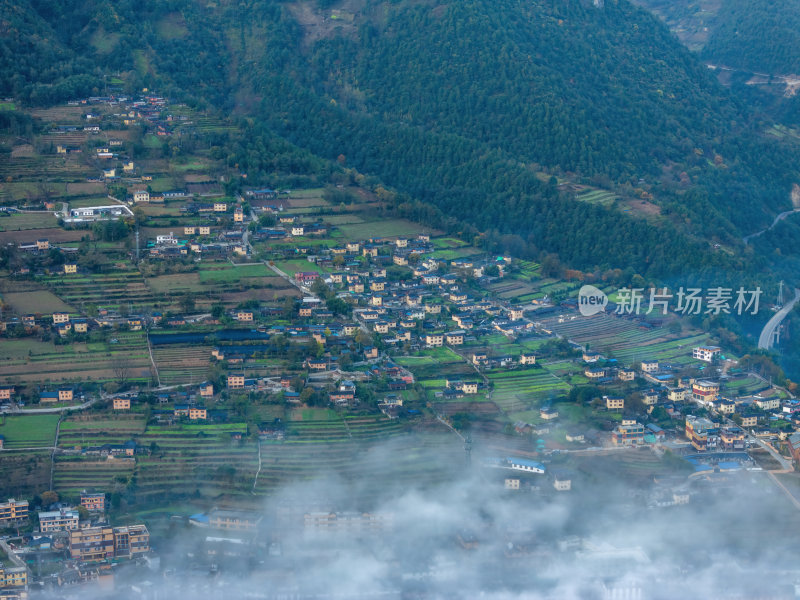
0, 0, 798, 279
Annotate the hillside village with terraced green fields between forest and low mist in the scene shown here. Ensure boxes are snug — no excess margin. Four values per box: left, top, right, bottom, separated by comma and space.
0, 93, 800, 599
